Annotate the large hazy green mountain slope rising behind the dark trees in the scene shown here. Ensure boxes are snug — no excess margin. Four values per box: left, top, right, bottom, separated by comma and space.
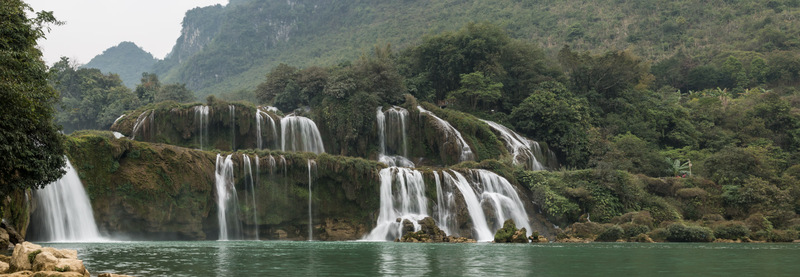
134, 0, 800, 97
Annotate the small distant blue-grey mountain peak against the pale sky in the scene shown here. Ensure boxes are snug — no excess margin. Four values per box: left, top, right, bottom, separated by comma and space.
81, 41, 156, 88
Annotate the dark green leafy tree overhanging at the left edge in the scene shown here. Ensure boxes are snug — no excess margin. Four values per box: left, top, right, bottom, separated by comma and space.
0, 0, 65, 199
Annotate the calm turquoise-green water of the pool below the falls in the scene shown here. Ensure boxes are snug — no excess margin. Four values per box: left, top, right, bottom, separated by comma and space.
43, 241, 800, 276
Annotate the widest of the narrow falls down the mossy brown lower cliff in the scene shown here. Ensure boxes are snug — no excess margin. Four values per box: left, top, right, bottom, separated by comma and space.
214, 154, 241, 240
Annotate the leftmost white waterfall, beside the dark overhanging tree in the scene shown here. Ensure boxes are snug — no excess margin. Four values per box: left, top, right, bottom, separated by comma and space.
33, 160, 104, 242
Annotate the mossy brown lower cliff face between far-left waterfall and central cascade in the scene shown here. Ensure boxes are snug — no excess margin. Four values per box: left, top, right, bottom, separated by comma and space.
25, 131, 383, 240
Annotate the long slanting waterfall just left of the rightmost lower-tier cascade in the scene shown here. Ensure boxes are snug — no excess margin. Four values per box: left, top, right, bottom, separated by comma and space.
442, 171, 494, 241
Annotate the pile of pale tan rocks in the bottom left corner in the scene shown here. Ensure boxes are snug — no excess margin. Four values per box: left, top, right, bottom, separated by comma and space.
10, 242, 90, 277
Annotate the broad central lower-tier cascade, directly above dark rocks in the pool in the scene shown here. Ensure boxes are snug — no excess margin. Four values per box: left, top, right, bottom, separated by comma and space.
364, 167, 428, 241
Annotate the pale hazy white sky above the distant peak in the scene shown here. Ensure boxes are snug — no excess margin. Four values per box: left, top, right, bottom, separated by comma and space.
25, 0, 228, 65
